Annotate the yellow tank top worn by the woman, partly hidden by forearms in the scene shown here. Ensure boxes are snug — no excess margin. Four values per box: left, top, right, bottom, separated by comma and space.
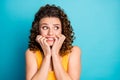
35, 51, 68, 80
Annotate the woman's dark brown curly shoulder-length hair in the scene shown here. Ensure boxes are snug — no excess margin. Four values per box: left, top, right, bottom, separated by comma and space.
28, 4, 74, 56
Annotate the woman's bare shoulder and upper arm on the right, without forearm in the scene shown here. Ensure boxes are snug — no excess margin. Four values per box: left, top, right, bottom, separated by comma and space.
68, 46, 81, 80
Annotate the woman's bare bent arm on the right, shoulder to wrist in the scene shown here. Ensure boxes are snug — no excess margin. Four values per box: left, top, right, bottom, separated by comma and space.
52, 46, 81, 80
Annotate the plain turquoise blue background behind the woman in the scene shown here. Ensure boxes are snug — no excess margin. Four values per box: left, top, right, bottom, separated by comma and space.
0, 0, 120, 80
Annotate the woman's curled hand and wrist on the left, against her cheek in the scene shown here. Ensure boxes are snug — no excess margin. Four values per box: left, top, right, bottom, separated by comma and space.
36, 35, 51, 57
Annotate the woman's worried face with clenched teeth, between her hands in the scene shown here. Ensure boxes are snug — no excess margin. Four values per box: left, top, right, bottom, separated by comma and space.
39, 17, 62, 46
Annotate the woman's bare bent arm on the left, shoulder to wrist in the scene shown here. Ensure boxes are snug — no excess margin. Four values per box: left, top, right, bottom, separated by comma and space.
26, 49, 50, 80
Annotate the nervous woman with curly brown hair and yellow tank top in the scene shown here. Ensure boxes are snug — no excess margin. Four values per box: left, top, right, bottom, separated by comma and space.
26, 4, 81, 80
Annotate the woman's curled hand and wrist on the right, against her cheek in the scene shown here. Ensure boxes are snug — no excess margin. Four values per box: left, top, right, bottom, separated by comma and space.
52, 34, 66, 54
